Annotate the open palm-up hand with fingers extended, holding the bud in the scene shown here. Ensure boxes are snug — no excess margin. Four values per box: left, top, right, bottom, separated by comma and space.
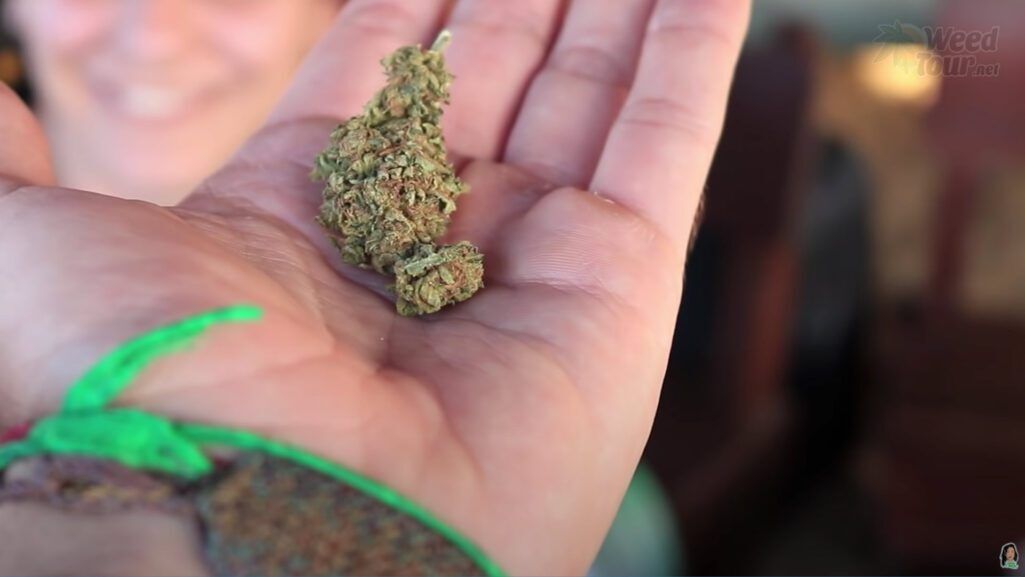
0, 0, 749, 574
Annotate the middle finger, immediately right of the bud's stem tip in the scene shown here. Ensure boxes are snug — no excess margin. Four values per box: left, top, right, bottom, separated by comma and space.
445, 0, 569, 160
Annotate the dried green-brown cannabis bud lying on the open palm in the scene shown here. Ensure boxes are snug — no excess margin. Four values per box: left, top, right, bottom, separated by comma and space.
312, 32, 484, 316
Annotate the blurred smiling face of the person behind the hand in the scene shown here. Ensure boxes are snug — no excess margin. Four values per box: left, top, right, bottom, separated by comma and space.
8, 0, 341, 201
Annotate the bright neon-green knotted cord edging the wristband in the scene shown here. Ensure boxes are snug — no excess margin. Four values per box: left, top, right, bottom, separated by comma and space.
0, 305, 503, 575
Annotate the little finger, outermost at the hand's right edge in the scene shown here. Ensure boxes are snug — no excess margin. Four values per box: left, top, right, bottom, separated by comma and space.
590, 0, 749, 251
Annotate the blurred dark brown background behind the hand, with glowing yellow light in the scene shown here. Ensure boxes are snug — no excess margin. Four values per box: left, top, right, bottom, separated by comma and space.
0, 0, 1025, 575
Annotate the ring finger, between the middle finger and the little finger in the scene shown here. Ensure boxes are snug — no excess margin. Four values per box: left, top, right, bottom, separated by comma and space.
505, 0, 654, 187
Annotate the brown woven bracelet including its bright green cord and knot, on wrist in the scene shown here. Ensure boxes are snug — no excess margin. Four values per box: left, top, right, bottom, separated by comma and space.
0, 305, 503, 575
